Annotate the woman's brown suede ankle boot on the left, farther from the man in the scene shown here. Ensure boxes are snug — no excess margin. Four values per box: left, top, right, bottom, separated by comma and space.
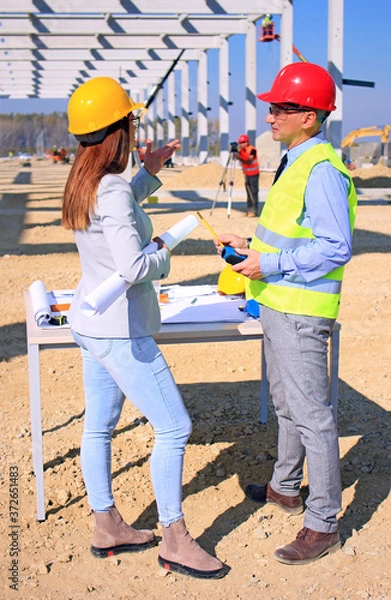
91, 506, 157, 558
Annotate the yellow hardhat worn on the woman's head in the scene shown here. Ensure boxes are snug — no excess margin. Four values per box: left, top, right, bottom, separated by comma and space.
68, 77, 145, 136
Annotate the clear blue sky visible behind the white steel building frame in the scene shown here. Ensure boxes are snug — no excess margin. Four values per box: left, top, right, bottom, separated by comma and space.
0, 0, 391, 140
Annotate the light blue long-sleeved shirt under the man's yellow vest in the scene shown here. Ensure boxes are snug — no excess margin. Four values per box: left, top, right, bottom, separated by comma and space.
260, 132, 352, 282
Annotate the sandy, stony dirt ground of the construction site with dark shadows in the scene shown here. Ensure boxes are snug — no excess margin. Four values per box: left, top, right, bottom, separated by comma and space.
0, 160, 391, 600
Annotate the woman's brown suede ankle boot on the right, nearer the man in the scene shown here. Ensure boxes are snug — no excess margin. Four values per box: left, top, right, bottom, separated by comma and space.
158, 519, 227, 579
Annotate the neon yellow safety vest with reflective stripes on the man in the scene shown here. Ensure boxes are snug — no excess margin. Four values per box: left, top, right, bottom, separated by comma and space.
246, 144, 357, 319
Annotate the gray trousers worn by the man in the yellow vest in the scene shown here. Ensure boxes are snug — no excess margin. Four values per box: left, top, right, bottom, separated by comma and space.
260, 306, 342, 533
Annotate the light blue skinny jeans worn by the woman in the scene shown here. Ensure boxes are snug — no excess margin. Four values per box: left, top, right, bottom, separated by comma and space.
72, 331, 192, 526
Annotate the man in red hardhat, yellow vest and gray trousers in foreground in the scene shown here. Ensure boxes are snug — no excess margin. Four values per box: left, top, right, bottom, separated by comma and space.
215, 63, 357, 565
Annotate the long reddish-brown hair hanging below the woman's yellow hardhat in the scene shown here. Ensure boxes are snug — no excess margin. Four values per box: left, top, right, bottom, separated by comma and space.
62, 117, 130, 230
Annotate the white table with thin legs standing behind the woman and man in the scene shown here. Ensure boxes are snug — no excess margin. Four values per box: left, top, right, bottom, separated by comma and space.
24, 292, 341, 521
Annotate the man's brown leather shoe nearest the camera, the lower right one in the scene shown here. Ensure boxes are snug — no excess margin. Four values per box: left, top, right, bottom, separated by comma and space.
274, 527, 341, 565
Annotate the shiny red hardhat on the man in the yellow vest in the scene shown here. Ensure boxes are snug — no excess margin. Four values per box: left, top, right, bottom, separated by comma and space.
257, 62, 336, 111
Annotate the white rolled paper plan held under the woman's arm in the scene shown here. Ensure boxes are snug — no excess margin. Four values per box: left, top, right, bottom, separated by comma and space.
81, 215, 198, 317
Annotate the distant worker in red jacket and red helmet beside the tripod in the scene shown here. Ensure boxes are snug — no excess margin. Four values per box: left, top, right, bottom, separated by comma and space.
235, 133, 259, 217
